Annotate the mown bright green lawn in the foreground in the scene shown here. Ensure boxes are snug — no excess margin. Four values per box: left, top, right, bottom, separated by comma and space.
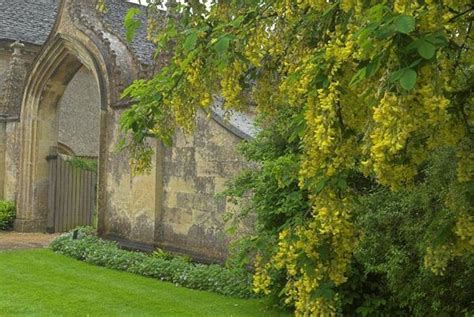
0, 249, 285, 317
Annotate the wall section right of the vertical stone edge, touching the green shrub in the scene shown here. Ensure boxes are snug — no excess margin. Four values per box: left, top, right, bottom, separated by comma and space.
156, 115, 246, 261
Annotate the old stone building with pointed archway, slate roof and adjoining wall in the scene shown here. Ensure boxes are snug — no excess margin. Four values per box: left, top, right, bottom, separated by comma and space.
0, 0, 252, 261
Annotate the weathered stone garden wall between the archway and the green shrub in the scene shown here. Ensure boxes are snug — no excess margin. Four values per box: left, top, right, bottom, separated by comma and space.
100, 111, 248, 261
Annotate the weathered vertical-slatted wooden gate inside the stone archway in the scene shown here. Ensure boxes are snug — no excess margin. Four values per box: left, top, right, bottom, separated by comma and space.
47, 154, 97, 232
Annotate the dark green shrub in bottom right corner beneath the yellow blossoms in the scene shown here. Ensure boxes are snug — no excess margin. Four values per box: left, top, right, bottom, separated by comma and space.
349, 150, 474, 316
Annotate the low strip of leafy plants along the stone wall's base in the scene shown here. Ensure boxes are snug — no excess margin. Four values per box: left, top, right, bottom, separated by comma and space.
50, 228, 254, 298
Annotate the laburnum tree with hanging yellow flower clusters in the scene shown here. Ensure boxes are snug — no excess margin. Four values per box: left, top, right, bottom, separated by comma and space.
116, 0, 474, 316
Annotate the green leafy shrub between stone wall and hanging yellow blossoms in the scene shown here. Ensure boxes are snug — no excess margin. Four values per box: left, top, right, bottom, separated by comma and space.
223, 110, 311, 305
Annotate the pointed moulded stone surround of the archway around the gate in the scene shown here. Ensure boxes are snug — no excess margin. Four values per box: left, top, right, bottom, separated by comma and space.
15, 0, 139, 232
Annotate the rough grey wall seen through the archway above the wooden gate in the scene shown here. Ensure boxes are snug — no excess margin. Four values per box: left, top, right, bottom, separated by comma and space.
58, 67, 100, 156
